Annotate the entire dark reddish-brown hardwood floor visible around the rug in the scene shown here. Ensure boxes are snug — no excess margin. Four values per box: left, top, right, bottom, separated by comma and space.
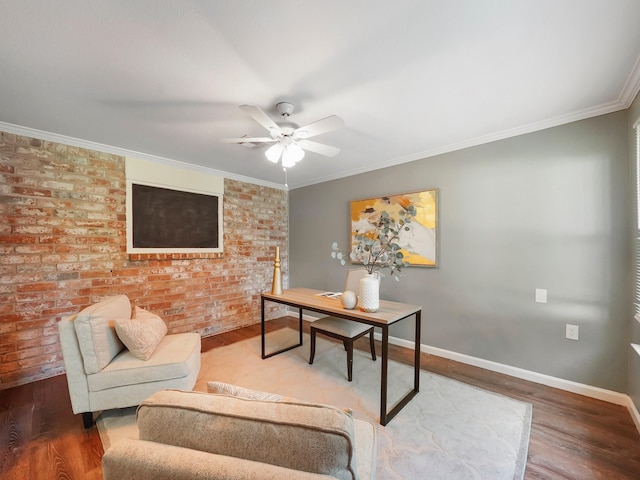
0, 319, 640, 480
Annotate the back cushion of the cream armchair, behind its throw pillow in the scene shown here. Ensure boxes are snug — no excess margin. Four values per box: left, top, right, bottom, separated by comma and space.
74, 295, 131, 375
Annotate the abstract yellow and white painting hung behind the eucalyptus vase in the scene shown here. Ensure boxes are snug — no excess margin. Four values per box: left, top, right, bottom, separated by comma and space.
350, 188, 439, 268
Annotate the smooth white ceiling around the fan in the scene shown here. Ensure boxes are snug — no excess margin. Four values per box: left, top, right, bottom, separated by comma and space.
0, 0, 640, 188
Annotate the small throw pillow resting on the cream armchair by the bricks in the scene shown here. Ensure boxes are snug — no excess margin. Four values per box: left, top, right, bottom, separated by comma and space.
115, 307, 167, 360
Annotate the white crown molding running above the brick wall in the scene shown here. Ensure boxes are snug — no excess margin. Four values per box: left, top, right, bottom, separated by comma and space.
0, 122, 287, 190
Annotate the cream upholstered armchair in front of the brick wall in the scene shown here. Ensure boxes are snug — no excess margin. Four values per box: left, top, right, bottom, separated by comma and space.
58, 295, 201, 428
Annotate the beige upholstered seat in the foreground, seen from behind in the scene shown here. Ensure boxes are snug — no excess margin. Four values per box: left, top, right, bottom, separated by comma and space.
102, 390, 376, 480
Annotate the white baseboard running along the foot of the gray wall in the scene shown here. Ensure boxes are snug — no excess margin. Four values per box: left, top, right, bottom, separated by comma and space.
296, 313, 640, 432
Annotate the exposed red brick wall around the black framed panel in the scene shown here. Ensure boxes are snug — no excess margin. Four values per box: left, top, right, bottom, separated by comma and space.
0, 132, 288, 389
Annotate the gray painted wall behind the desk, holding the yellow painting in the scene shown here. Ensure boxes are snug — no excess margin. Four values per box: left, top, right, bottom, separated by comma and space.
289, 111, 632, 392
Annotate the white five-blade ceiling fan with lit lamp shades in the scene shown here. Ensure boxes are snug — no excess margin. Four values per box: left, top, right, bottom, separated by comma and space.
220, 102, 344, 168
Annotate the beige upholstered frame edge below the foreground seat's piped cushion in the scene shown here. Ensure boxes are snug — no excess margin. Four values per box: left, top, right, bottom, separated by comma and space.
102, 440, 333, 480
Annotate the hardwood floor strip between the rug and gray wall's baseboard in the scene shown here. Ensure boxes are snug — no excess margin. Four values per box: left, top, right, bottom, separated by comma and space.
376, 343, 640, 480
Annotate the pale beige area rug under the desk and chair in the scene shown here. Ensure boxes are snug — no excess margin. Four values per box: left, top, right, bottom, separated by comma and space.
97, 329, 531, 480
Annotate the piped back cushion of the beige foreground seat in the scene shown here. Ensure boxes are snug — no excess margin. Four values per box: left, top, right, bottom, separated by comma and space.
137, 390, 357, 480
